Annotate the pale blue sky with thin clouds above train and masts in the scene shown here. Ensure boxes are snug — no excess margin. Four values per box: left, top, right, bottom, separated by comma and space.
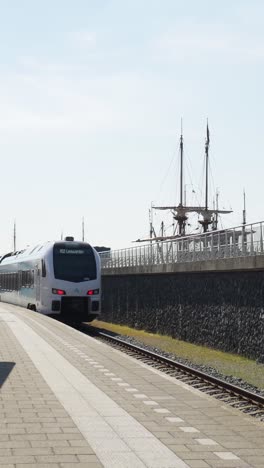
0, 0, 264, 254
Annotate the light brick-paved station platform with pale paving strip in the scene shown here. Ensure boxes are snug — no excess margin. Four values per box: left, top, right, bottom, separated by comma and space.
0, 303, 264, 468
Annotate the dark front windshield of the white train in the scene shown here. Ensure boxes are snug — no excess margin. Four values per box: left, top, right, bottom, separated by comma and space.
53, 242, 96, 283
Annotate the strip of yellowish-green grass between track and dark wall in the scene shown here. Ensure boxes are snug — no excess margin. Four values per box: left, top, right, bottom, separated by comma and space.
92, 320, 264, 390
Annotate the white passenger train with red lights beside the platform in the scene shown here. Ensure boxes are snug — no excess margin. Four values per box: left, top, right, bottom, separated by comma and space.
0, 237, 101, 322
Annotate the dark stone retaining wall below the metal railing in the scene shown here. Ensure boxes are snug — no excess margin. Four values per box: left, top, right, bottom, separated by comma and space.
102, 270, 264, 361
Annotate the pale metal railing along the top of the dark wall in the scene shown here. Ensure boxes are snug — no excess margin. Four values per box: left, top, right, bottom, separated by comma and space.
100, 221, 264, 269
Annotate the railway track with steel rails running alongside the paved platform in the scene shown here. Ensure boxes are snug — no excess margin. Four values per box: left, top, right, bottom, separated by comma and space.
81, 324, 264, 421
